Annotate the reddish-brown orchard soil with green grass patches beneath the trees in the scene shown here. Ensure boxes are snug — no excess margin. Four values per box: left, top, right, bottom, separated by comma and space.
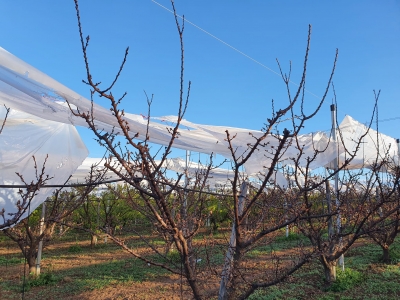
0, 232, 400, 300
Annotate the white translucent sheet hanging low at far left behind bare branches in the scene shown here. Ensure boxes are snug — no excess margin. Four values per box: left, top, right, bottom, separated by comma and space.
0, 107, 88, 224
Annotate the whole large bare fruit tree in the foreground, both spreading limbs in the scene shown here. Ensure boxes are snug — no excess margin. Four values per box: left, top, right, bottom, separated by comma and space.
70, 0, 384, 299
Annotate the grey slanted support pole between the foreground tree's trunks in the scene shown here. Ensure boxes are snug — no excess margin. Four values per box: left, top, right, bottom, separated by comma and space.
218, 181, 248, 300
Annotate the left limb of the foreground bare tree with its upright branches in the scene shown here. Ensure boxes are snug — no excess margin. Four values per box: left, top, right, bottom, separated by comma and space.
71, 1, 206, 298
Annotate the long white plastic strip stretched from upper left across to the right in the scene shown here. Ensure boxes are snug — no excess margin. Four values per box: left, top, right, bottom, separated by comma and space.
0, 48, 397, 175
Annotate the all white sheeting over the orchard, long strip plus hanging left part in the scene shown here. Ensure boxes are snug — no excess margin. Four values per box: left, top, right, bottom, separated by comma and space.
0, 47, 398, 226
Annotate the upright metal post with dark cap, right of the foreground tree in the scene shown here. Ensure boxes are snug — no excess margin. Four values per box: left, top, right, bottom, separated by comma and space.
331, 104, 344, 271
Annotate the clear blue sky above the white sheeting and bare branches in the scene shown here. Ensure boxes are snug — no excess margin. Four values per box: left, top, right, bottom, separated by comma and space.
0, 0, 400, 156
